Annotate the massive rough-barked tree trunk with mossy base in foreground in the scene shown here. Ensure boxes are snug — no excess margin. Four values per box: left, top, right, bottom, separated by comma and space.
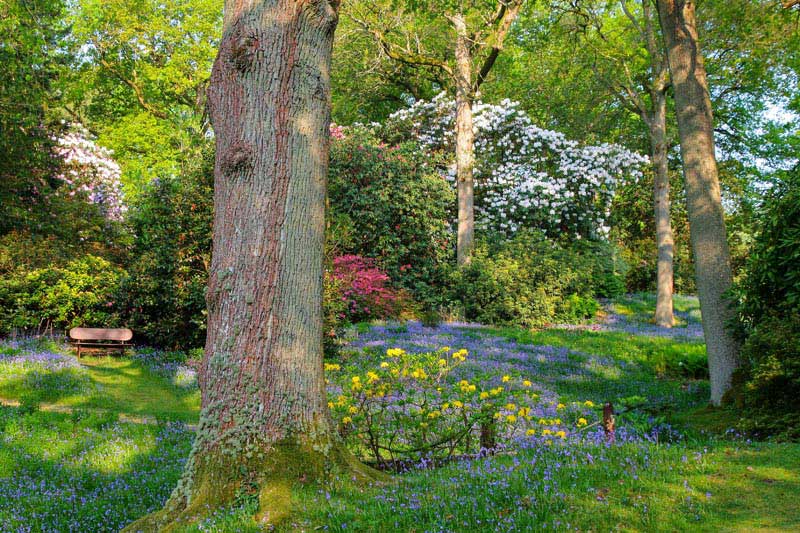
127, 0, 382, 531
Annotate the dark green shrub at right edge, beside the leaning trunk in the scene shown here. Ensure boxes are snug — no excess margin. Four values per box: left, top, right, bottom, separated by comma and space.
728, 169, 800, 439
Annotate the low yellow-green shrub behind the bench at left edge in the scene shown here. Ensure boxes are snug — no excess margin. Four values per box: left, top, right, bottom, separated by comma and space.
0, 255, 124, 333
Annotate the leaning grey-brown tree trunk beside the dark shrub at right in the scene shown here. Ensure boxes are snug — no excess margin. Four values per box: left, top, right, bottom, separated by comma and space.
658, 0, 739, 405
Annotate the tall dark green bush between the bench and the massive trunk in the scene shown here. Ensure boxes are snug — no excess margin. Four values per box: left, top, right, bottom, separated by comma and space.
119, 152, 214, 349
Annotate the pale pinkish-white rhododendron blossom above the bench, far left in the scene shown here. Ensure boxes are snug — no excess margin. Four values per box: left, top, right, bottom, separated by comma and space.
55, 129, 127, 220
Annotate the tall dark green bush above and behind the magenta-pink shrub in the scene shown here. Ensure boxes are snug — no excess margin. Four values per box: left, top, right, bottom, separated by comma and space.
328, 128, 455, 303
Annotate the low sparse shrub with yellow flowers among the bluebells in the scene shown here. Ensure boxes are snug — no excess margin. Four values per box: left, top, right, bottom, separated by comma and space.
325, 347, 594, 465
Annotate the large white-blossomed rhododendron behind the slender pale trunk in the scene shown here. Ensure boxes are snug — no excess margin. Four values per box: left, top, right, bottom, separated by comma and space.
381, 93, 648, 238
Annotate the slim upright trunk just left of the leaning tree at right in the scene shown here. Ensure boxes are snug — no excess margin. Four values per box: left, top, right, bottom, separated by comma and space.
649, 91, 675, 328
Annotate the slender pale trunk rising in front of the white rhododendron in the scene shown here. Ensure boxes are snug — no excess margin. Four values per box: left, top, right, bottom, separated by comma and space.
452, 14, 475, 266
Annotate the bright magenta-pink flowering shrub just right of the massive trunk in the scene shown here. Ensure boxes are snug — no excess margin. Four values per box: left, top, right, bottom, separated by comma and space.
333, 255, 400, 322
